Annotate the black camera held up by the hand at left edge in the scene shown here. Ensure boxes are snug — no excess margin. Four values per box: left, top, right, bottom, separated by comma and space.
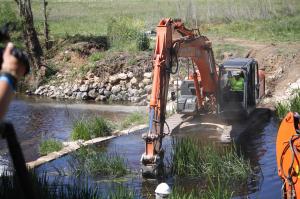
0, 23, 30, 74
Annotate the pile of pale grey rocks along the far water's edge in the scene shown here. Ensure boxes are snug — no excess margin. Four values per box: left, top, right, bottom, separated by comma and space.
34, 72, 152, 104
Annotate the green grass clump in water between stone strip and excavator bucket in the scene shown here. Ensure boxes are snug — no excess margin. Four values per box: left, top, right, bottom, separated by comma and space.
69, 147, 128, 177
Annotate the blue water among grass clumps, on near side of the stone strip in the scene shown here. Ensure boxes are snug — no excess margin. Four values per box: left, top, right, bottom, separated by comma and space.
38, 114, 281, 198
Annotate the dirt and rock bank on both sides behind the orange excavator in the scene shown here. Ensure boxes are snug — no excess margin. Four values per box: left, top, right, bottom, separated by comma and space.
34, 35, 300, 107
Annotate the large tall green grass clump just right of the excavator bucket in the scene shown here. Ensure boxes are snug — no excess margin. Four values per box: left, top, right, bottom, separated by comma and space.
172, 138, 252, 182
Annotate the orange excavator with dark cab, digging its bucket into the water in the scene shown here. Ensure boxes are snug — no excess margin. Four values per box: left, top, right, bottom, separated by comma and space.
141, 18, 264, 176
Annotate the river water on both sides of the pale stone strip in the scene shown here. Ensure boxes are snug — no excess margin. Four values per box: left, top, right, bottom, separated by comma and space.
1, 97, 281, 199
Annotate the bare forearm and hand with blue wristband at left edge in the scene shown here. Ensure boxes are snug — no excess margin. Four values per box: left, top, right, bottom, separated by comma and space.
0, 43, 26, 120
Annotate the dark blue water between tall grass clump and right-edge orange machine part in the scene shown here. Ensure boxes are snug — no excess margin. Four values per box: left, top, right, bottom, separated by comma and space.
236, 119, 281, 198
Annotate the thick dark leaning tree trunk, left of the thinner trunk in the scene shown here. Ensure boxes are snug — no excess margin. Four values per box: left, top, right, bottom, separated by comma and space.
15, 0, 43, 70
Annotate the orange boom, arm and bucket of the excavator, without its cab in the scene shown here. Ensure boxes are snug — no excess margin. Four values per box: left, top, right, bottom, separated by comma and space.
141, 18, 218, 176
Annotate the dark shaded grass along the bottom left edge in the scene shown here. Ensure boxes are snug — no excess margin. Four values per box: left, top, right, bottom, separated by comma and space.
0, 172, 135, 199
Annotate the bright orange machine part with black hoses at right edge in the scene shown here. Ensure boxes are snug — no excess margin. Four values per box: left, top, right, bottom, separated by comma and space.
276, 112, 300, 199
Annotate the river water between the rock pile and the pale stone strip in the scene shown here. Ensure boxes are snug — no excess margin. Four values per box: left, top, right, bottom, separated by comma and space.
0, 96, 146, 163
